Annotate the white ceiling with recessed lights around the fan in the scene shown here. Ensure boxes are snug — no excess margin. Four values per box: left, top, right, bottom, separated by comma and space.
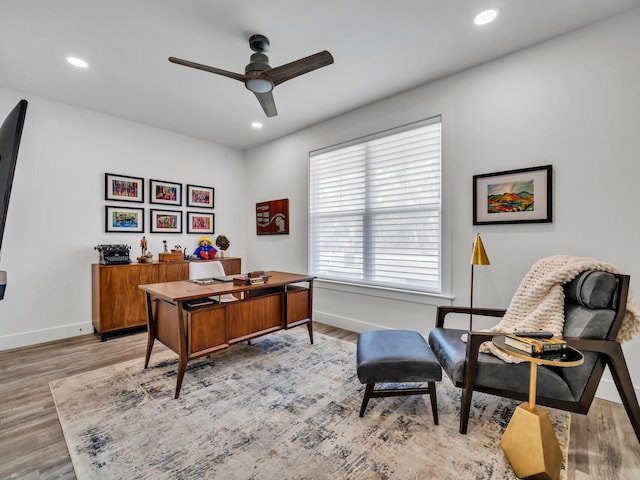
0, 0, 640, 149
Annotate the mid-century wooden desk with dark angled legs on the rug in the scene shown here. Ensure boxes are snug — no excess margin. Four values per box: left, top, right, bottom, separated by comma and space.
140, 272, 315, 398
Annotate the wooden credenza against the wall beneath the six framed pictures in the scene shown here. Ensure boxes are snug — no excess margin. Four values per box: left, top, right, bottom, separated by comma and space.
91, 257, 242, 340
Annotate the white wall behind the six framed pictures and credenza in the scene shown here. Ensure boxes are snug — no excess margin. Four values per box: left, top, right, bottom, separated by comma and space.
0, 92, 246, 350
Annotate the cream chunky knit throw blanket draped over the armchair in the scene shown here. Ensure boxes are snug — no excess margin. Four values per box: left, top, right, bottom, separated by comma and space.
470, 255, 640, 363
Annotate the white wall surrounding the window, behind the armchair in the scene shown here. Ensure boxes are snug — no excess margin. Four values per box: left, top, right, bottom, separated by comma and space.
246, 9, 640, 399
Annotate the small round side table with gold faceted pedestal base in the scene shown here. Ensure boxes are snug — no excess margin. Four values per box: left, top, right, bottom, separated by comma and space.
492, 335, 584, 480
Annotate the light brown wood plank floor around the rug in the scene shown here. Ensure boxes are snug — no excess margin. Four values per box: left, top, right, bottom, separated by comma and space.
0, 323, 640, 480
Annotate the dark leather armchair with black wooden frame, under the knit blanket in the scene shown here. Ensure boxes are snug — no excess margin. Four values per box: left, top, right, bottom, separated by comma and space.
429, 271, 640, 442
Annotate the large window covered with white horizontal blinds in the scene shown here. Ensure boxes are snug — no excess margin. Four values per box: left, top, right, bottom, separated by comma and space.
309, 117, 441, 293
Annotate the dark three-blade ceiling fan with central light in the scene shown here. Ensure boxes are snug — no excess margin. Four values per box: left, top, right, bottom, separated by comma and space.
169, 35, 333, 117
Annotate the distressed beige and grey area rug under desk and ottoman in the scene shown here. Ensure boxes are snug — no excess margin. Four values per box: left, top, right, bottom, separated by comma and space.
50, 328, 569, 480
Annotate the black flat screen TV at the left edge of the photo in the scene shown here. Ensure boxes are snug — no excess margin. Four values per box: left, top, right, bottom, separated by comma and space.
0, 100, 27, 253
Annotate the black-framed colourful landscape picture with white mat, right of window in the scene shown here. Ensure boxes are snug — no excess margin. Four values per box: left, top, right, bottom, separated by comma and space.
473, 165, 552, 225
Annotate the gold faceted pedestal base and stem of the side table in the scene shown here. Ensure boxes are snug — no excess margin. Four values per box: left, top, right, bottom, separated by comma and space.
500, 363, 562, 480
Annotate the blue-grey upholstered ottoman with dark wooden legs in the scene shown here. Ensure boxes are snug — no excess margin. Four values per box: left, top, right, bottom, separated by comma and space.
356, 330, 442, 425
